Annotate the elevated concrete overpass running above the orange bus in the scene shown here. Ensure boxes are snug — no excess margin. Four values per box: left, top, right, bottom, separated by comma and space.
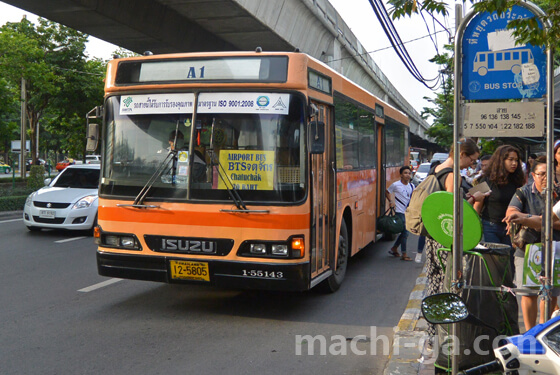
3, 0, 434, 141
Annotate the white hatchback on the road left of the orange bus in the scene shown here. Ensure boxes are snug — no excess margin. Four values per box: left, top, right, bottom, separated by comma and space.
23, 164, 100, 231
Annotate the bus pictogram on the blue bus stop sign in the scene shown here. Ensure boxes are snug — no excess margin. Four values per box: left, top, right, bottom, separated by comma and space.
473, 48, 535, 76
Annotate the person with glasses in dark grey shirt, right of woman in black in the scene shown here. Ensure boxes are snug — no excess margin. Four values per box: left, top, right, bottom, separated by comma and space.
503, 156, 560, 330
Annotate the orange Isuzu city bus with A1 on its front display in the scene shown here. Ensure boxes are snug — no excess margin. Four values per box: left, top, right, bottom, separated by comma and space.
88, 52, 409, 291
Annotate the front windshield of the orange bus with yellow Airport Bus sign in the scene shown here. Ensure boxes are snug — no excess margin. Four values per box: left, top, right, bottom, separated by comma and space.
100, 92, 307, 204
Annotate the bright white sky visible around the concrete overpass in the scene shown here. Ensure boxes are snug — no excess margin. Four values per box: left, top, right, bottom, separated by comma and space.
0, 0, 472, 112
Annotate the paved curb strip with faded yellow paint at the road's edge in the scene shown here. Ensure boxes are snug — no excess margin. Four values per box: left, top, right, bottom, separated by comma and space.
383, 265, 434, 375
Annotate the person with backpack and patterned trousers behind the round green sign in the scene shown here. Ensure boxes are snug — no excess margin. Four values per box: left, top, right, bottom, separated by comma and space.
425, 138, 490, 337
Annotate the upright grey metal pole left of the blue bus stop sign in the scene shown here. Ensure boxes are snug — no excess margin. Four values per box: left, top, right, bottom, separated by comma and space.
451, 4, 463, 375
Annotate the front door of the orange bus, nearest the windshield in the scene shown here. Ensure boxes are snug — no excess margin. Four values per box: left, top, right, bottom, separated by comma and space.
311, 103, 336, 285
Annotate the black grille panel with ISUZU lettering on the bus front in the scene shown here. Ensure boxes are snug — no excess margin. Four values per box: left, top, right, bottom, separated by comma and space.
144, 234, 233, 256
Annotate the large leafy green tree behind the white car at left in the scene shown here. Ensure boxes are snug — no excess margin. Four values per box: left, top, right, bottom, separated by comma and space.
0, 18, 104, 163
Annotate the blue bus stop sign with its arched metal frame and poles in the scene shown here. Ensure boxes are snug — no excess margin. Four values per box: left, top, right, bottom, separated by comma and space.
458, 2, 554, 375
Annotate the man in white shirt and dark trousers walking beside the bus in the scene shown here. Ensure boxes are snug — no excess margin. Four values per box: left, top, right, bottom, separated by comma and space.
385, 166, 414, 261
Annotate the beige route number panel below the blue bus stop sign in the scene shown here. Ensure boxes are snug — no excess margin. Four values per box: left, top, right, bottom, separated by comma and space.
462, 102, 544, 137
